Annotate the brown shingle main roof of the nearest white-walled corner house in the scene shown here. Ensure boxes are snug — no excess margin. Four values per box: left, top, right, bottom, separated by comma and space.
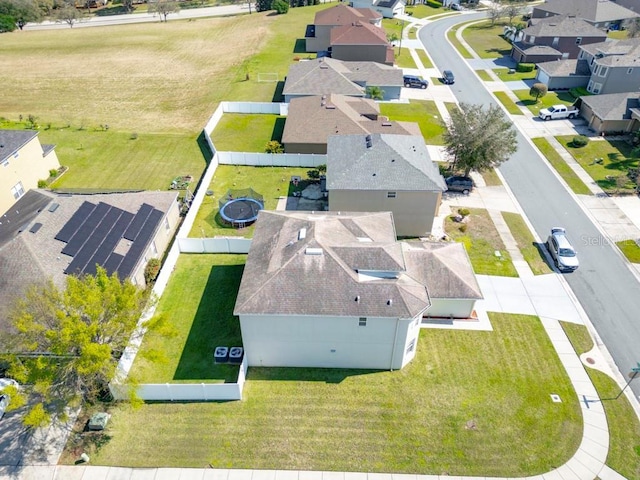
234, 210, 431, 318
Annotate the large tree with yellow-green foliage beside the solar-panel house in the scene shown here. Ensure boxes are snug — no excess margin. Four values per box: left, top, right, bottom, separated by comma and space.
2, 267, 163, 427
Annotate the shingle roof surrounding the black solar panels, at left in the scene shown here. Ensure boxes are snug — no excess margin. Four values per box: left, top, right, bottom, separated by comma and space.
0, 190, 177, 328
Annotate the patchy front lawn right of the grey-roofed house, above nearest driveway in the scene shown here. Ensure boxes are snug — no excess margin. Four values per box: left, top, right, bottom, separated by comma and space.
444, 208, 518, 277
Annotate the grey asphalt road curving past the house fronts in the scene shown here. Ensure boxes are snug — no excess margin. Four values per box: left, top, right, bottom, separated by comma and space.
419, 13, 640, 397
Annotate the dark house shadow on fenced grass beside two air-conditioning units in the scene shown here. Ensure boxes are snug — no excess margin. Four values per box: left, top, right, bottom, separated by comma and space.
173, 265, 244, 383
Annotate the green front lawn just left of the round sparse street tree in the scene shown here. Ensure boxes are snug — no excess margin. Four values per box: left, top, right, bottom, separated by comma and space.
380, 100, 444, 145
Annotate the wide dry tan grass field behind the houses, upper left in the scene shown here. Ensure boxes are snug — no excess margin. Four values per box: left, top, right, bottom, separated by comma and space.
0, 4, 334, 133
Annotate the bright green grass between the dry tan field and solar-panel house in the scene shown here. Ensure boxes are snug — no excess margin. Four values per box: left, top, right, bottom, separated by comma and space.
39, 127, 211, 190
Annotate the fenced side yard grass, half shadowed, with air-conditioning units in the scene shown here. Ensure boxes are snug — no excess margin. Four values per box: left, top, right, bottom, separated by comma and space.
131, 254, 246, 383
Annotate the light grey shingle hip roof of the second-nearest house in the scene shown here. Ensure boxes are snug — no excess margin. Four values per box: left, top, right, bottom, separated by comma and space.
327, 134, 447, 192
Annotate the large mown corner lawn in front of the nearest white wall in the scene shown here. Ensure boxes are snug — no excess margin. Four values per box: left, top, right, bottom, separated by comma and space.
77, 314, 582, 477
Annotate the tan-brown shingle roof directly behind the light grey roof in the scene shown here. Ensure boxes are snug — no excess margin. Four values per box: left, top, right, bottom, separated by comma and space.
282, 94, 420, 145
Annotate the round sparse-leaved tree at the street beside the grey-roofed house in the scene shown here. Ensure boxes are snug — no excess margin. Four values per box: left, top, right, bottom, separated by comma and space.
443, 103, 518, 176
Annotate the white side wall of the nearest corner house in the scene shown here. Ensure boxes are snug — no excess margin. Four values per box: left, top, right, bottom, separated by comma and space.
240, 315, 420, 370
